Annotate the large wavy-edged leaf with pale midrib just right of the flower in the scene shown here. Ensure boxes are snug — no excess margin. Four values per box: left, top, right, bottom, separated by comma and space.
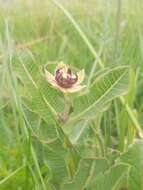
69, 66, 129, 122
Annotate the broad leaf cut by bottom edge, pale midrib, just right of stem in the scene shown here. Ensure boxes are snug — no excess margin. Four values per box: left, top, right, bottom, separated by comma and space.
61, 158, 108, 190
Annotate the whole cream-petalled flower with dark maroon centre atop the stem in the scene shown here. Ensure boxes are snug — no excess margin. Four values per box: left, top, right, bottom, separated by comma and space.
45, 62, 85, 93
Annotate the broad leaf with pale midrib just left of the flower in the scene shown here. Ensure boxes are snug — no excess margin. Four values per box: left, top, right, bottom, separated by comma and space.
14, 52, 64, 123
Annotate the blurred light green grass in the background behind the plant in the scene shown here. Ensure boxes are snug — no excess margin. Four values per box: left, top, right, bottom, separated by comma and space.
0, 0, 143, 189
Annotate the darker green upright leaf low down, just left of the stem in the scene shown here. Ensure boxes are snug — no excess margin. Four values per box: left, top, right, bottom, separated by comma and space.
44, 139, 68, 189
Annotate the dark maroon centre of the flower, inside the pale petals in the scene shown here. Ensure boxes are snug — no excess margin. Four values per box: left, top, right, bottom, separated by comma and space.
55, 69, 78, 88
